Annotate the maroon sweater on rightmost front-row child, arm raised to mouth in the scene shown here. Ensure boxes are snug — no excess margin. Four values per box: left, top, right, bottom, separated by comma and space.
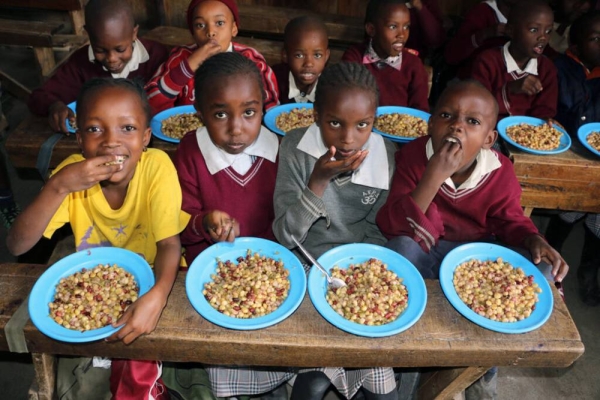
376, 136, 538, 251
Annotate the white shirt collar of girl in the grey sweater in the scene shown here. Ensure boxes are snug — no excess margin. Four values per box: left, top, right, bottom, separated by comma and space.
297, 123, 390, 190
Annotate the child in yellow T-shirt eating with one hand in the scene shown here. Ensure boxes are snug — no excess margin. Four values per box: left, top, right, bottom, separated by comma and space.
7, 78, 189, 399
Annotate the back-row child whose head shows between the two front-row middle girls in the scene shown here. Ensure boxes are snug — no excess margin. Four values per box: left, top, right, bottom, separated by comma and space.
273, 16, 329, 104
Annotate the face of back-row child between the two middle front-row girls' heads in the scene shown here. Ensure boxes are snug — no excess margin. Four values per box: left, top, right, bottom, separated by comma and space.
283, 29, 329, 89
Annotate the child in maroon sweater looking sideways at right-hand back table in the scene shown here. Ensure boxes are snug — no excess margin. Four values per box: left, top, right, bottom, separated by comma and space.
473, 0, 558, 119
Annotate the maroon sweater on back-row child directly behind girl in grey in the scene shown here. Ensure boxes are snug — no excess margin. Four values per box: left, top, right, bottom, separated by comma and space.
342, 43, 429, 111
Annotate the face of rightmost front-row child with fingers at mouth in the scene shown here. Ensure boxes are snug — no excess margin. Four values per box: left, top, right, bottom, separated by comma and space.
429, 87, 497, 173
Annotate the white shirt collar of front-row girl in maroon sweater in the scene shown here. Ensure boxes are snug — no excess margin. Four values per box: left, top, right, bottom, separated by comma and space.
196, 126, 279, 175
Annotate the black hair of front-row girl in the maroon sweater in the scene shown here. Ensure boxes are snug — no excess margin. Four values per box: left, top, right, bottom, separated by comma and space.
194, 51, 265, 109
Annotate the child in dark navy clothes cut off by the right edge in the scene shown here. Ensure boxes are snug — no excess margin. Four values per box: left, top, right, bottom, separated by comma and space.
546, 11, 600, 306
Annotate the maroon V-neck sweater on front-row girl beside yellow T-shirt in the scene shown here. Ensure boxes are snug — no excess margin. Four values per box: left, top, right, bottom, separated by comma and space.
175, 131, 277, 266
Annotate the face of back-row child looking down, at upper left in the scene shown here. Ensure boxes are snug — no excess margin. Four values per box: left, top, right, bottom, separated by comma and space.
88, 18, 138, 74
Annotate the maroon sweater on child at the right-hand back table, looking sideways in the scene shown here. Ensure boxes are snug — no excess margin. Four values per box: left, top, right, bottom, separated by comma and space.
473, 47, 558, 119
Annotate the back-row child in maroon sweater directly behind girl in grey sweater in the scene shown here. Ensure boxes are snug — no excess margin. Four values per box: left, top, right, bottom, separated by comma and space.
342, 0, 429, 111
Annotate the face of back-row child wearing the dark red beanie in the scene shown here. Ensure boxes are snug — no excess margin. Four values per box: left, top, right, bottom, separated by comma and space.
192, 1, 238, 51
